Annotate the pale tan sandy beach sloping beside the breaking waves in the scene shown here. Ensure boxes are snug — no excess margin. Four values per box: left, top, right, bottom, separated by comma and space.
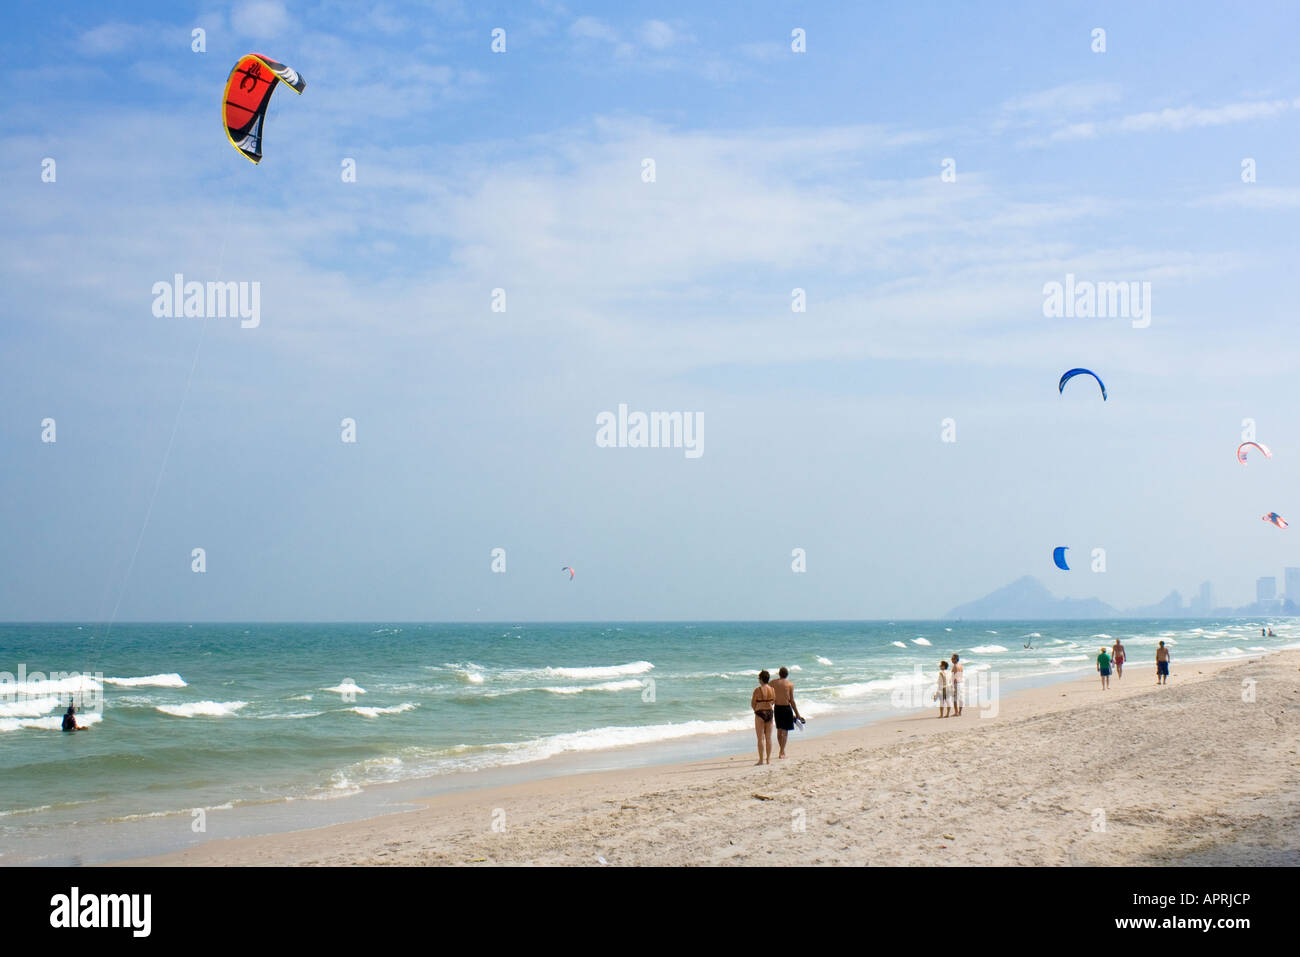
130, 651, 1300, 866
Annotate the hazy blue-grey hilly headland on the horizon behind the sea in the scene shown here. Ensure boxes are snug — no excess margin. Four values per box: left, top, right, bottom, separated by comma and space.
944, 575, 1300, 620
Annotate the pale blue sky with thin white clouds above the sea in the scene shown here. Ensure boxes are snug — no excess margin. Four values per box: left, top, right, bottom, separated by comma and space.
0, 0, 1300, 622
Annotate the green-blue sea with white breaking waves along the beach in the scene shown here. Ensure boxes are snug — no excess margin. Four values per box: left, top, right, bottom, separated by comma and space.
0, 619, 1300, 865
